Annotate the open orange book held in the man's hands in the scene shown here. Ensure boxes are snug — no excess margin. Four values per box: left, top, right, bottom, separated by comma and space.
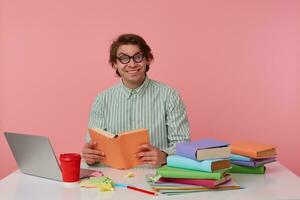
88, 128, 149, 169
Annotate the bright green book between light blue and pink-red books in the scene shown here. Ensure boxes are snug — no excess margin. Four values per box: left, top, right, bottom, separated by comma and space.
156, 165, 225, 179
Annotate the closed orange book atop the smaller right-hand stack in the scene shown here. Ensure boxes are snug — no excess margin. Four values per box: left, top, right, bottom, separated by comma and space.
230, 141, 276, 158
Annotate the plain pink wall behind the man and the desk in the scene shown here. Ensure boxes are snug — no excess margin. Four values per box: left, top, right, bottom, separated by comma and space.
0, 0, 300, 178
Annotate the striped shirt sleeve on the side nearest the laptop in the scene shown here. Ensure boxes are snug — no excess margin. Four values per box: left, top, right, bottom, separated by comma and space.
85, 94, 106, 142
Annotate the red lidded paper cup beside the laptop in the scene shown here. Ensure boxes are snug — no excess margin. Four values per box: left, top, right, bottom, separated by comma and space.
59, 153, 81, 183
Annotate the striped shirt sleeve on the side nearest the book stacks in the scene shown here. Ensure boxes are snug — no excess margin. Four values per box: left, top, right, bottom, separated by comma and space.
162, 91, 190, 155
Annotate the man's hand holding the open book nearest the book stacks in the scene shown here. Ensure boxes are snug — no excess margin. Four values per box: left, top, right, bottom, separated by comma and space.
137, 144, 167, 167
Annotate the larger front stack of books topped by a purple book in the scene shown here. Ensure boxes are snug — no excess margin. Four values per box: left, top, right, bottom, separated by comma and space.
150, 139, 240, 195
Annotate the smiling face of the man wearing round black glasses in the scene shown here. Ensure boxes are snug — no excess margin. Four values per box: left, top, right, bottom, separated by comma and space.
113, 44, 151, 88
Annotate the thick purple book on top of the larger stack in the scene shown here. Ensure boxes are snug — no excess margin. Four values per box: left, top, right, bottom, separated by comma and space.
176, 139, 230, 160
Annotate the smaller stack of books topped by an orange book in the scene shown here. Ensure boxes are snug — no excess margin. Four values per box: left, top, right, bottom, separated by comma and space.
229, 141, 276, 174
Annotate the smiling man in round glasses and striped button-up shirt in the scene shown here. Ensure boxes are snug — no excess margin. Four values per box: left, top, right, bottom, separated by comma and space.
82, 34, 190, 167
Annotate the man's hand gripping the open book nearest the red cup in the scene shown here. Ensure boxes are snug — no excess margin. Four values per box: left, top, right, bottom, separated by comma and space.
82, 141, 105, 165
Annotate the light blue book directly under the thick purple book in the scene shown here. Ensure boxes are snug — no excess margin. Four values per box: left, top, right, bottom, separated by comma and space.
167, 155, 231, 172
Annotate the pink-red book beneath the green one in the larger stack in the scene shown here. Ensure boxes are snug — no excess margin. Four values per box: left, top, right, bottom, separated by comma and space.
159, 174, 231, 188
